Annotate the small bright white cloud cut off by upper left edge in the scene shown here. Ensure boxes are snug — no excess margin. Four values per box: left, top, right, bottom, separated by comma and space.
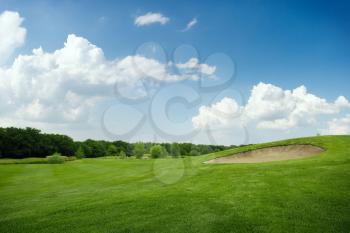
0, 11, 27, 64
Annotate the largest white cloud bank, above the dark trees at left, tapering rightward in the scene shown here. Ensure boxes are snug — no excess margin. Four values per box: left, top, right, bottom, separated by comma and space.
0, 34, 213, 122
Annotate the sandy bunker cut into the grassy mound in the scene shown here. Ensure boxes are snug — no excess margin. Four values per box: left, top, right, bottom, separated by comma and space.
205, 145, 324, 163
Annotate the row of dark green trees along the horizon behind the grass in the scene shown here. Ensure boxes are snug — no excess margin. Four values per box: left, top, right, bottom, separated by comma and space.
0, 127, 235, 158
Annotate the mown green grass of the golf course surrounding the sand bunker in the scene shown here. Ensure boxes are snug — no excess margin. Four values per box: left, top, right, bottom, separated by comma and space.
0, 136, 350, 233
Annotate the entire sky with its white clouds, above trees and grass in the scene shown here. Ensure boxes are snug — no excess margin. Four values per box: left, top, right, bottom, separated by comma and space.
0, 0, 350, 144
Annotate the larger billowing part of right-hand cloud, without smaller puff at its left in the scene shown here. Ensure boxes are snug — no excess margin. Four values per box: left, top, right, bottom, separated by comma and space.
245, 83, 347, 130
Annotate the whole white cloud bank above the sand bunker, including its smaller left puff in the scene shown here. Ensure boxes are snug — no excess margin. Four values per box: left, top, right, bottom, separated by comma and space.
192, 83, 350, 130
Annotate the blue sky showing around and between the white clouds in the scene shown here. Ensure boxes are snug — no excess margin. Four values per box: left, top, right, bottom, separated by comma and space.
0, 0, 350, 143
